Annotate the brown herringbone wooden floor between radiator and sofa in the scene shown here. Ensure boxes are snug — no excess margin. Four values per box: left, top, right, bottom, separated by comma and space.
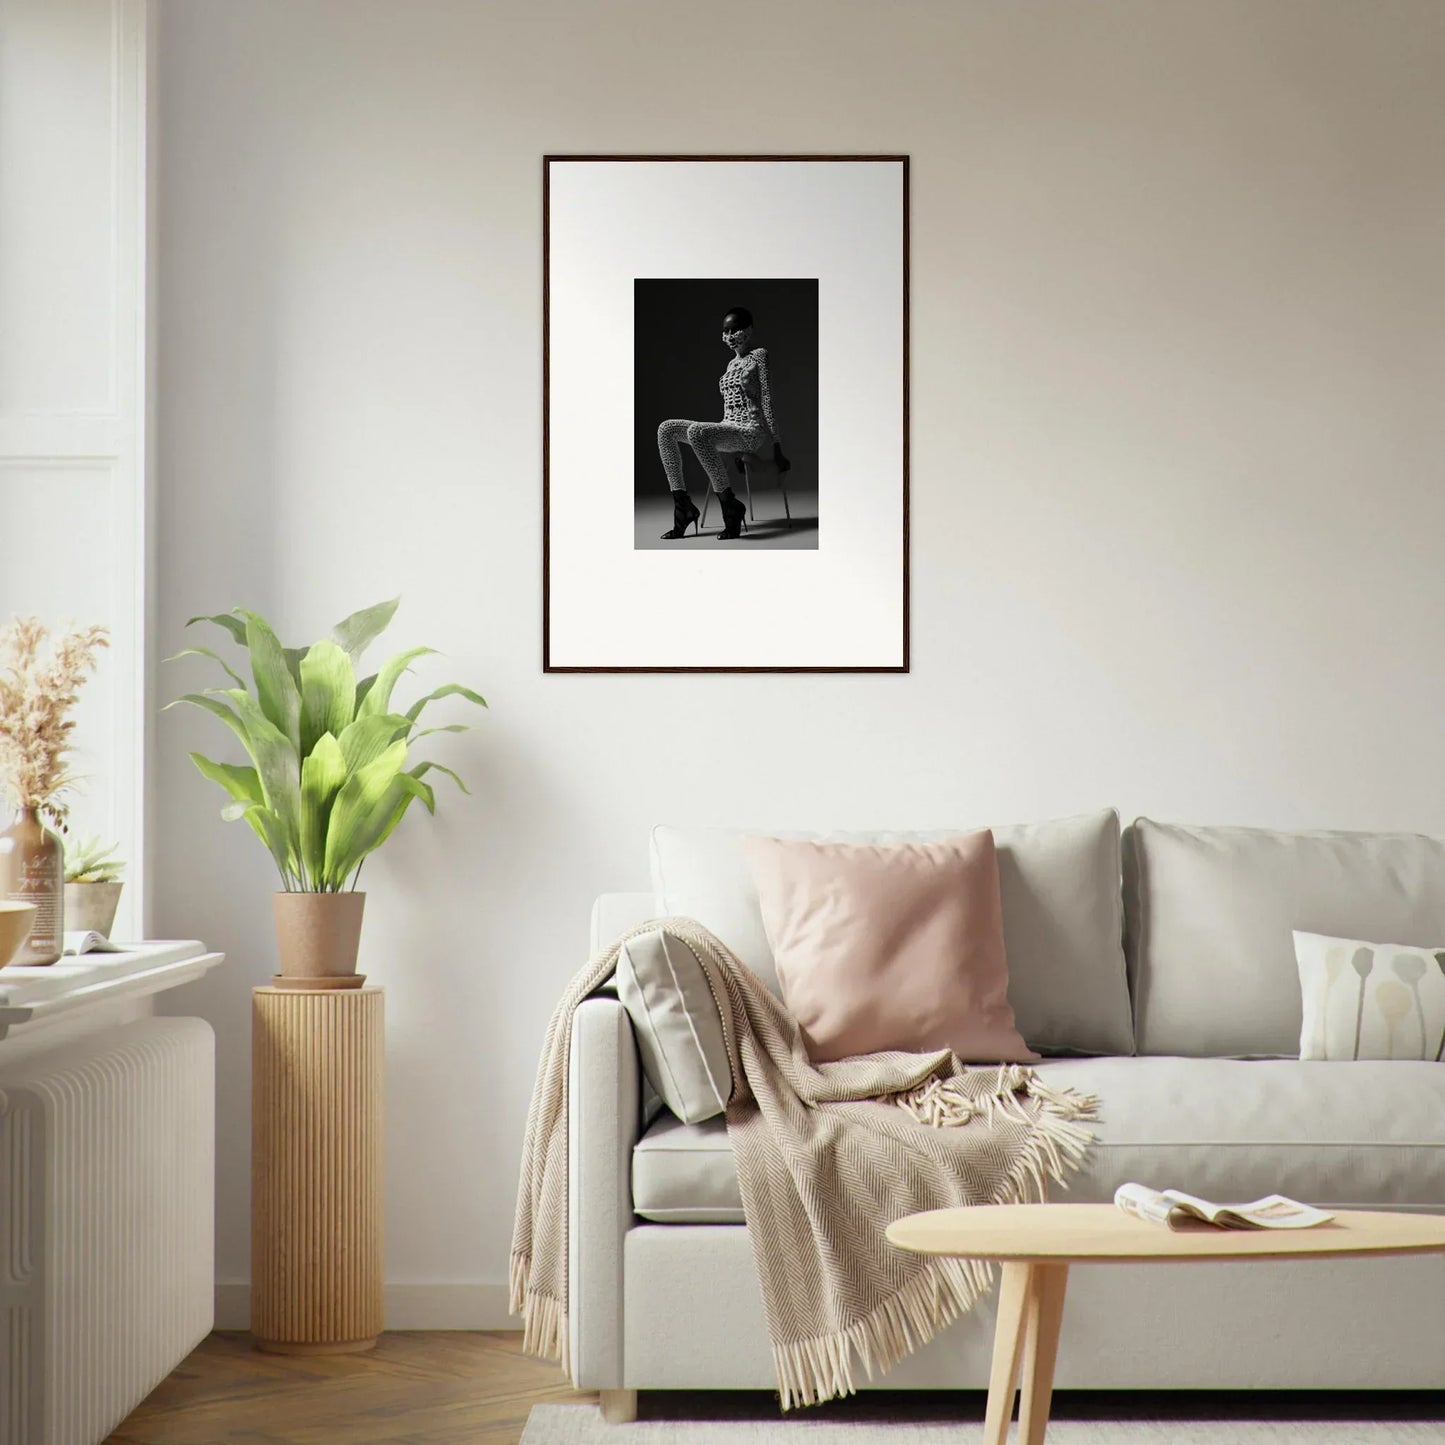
107, 1331, 597, 1445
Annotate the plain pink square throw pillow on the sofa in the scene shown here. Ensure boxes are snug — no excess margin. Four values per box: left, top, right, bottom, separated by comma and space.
743, 829, 1038, 1064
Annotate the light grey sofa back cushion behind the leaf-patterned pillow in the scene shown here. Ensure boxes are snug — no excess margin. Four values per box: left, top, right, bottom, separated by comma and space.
1124, 818, 1445, 1058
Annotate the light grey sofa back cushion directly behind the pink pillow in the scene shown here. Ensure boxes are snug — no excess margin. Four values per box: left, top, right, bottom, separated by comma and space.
652, 809, 1133, 1053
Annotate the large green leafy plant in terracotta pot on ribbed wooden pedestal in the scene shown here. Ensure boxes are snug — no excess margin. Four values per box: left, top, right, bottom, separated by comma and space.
169, 598, 487, 978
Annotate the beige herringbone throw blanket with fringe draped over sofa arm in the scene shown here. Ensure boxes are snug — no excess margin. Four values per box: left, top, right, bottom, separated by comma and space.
512, 918, 1097, 1409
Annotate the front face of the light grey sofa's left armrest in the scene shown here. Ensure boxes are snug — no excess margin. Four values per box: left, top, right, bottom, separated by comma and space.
566, 997, 642, 1390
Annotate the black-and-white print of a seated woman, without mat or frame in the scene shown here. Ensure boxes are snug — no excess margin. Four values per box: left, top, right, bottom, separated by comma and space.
633, 279, 818, 553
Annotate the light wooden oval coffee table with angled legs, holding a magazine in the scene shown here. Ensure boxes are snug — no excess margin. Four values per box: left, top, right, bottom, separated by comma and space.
887, 1204, 1445, 1445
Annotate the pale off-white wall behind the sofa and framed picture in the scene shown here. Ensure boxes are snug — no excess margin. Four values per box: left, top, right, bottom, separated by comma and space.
155, 0, 1445, 1324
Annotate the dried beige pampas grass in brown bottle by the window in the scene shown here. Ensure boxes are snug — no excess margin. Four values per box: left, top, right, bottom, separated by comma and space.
0, 617, 110, 828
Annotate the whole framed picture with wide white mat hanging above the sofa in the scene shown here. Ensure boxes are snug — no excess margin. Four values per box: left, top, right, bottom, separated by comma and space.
542, 156, 909, 672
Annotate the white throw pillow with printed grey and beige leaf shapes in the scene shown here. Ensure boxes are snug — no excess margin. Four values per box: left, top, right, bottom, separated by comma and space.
1295, 932, 1445, 1064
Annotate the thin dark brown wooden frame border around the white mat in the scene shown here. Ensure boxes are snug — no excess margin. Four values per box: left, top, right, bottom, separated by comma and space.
542, 153, 912, 673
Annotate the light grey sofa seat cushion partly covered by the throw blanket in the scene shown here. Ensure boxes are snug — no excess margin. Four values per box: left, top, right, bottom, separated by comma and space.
633, 1058, 1445, 1224
